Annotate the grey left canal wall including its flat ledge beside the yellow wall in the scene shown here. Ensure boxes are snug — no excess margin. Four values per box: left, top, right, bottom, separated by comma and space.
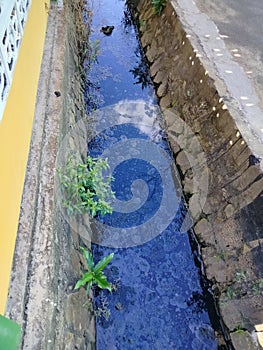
6, 1, 95, 350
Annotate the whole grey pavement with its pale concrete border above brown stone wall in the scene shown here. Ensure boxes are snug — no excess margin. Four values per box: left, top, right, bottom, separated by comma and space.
172, 0, 263, 161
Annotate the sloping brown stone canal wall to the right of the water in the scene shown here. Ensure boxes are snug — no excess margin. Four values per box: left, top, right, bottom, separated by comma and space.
136, 0, 263, 349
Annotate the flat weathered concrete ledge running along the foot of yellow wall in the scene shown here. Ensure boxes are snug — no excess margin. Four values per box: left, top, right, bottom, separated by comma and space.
6, 4, 65, 349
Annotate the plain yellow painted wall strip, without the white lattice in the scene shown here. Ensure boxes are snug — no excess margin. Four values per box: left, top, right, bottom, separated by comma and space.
0, 0, 49, 314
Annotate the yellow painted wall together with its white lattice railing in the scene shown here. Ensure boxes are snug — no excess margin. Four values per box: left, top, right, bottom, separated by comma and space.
0, 0, 49, 314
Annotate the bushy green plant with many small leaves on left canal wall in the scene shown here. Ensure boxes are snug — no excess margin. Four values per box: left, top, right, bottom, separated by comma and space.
58, 156, 114, 217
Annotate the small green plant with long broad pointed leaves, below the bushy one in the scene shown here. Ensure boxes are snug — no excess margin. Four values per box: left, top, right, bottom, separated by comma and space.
74, 247, 114, 294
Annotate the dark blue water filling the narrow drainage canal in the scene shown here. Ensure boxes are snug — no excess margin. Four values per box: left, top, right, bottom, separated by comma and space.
86, 0, 221, 350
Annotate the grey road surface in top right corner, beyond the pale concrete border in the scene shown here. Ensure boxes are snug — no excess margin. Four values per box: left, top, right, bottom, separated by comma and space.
197, 0, 263, 110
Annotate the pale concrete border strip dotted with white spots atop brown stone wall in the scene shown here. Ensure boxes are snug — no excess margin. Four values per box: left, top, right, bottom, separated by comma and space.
170, 0, 263, 165
